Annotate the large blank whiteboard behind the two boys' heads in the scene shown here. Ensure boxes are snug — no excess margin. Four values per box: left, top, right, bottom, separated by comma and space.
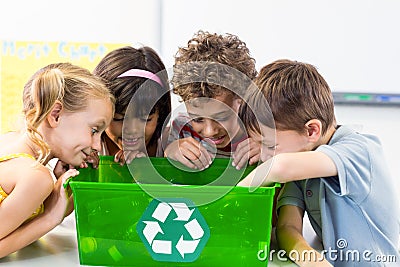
161, 0, 400, 94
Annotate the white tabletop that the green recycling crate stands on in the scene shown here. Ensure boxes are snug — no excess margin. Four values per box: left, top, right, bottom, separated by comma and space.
0, 213, 320, 267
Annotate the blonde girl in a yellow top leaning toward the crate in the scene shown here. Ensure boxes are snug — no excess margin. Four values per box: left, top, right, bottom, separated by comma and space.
0, 63, 114, 258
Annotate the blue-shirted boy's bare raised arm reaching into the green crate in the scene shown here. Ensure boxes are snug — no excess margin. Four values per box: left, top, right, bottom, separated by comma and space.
238, 151, 337, 187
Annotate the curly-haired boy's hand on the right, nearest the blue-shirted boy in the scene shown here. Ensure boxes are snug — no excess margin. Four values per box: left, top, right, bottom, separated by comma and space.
232, 138, 261, 170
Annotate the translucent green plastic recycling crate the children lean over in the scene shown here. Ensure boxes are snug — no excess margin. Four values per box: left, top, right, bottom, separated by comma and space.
69, 156, 278, 266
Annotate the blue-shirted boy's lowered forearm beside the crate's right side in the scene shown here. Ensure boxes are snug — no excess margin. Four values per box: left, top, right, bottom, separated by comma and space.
276, 205, 332, 266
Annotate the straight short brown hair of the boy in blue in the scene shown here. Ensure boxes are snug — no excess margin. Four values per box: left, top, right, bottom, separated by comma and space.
239, 59, 336, 134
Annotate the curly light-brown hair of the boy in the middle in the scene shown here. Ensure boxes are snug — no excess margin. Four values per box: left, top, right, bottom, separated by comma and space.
171, 31, 257, 101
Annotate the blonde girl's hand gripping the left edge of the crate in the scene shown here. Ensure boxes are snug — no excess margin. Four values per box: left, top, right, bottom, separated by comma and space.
44, 169, 79, 224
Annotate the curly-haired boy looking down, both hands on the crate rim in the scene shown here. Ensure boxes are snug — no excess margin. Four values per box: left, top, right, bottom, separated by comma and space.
165, 31, 260, 170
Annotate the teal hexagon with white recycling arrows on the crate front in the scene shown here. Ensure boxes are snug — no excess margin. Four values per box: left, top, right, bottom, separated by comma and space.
136, 198, 210, 262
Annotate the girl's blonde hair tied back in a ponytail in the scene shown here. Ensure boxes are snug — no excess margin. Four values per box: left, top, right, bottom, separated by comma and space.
23, 63, 114, 163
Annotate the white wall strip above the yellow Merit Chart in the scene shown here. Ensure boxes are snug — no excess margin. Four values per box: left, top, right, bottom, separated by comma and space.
0, 0, 161, 51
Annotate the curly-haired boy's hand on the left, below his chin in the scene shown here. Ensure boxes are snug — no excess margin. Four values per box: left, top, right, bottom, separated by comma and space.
165, 137, 212, 170
